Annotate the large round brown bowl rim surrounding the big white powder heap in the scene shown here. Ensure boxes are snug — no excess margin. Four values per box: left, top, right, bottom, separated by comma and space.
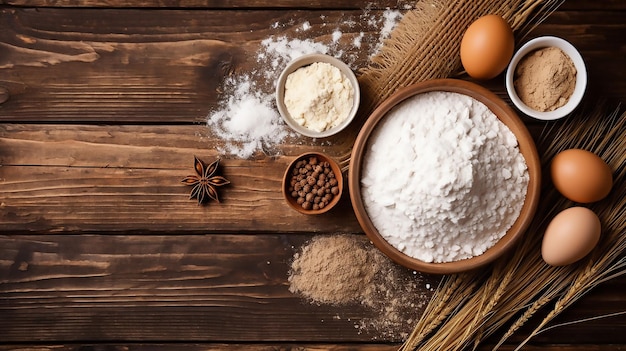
348, 79, 541, 274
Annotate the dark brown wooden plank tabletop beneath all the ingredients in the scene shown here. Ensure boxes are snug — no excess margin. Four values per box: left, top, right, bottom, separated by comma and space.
0, 0, 626, 351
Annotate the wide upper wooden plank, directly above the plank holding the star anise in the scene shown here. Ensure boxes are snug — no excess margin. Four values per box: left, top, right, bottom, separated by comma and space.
0, 9, 626, 124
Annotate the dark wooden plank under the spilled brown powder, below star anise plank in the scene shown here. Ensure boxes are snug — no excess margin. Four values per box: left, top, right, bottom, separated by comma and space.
0, 234, 436, 343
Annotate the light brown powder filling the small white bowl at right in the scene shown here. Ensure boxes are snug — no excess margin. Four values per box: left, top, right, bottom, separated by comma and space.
513, 47, 576, 112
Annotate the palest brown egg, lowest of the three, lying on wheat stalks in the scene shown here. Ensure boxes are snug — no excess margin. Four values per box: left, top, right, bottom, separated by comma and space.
541, 207, 601, 266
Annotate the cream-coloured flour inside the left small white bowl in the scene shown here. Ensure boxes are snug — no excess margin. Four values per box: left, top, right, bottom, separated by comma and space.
284, 62, 354, 132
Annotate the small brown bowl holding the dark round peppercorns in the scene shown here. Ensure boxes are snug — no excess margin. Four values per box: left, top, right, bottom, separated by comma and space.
282, 152, 343, 215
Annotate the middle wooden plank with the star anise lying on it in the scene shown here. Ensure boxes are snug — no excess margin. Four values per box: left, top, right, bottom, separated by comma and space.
0, 124, 361, 233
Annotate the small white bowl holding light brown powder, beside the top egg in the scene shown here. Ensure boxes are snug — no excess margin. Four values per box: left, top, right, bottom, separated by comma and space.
506, 36, 587, 121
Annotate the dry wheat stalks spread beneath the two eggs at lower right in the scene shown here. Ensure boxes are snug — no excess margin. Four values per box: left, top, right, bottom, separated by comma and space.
403, 103, 626, 351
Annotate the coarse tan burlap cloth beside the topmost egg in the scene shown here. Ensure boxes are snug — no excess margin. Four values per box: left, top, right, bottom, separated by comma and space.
359, 0, 562, 121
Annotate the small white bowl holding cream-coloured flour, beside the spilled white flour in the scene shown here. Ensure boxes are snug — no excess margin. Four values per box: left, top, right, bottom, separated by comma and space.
276, 54, 361, 138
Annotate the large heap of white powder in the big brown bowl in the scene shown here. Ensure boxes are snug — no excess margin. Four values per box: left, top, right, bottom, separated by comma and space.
361, 92, 529, 262
